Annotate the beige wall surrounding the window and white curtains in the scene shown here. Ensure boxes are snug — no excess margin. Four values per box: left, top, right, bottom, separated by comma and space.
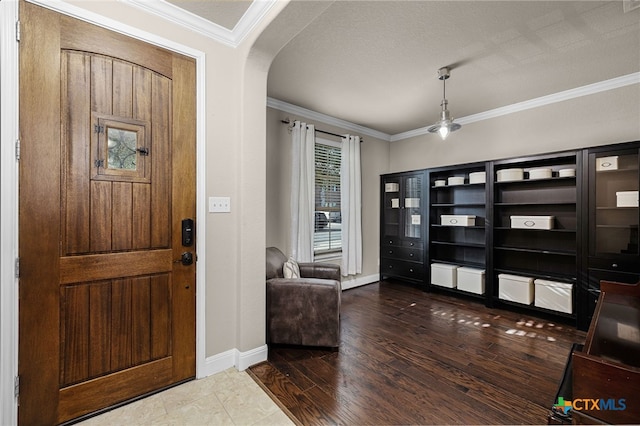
266, 108, 389, 288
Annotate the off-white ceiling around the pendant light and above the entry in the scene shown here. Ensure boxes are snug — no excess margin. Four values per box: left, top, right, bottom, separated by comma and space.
155, 0, 640, 135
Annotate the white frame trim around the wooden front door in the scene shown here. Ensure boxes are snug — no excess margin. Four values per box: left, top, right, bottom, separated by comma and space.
0, 0, 206, 424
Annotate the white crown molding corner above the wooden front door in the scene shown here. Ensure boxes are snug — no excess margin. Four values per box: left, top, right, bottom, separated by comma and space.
119, 0, 277, 48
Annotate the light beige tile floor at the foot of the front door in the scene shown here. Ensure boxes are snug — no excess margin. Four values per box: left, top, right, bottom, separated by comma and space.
78, 368, 294, 426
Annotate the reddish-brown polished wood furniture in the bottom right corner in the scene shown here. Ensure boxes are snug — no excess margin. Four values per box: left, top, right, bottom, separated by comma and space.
572, 281, 640, 424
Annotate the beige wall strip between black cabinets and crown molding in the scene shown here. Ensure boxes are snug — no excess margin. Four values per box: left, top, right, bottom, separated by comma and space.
389, 85, 640, 171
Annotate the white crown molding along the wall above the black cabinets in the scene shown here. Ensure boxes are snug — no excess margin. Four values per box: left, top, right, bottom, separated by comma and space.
390, 72, 640, 142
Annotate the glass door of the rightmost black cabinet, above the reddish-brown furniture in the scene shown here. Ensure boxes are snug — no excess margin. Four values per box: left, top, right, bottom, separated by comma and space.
590, 151, 639, 256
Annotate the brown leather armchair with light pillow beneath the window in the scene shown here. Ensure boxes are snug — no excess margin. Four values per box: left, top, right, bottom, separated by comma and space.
266, 247, 342, 348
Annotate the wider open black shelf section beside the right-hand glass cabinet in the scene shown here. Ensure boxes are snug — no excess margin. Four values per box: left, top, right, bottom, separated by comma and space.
492, 151, 581, 319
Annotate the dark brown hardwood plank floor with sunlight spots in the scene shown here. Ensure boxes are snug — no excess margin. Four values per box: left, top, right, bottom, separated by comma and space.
249, 281, 585, 425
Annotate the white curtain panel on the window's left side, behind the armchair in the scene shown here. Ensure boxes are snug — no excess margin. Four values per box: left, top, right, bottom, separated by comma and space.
291, 121, 315, 262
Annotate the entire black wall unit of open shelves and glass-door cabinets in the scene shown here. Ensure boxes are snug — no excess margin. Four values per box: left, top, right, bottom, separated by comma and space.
380, 141, 640, 330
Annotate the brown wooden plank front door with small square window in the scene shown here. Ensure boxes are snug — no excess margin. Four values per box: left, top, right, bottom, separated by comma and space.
18, 2, 196, 425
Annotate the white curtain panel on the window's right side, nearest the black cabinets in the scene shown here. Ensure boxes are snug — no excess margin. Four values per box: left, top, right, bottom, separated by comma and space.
340, 135, 362, 277
